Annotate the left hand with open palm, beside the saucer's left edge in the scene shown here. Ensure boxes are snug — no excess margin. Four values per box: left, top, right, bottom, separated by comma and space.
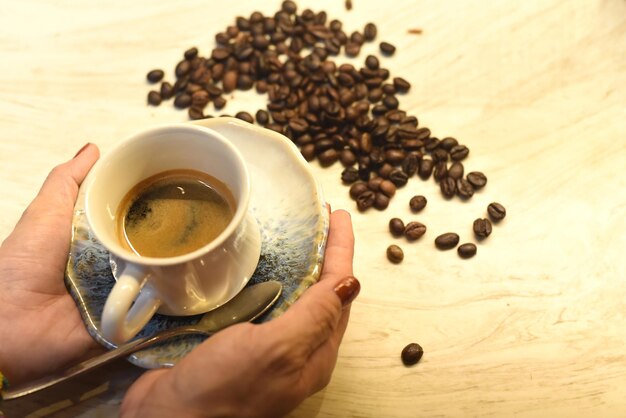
0, 144, 103, 384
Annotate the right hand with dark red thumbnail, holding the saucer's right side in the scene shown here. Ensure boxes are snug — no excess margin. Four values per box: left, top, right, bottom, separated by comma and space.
121, 211, 360, 418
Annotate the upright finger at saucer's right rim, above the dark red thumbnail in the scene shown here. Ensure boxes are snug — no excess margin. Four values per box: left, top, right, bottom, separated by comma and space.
320, 210, 354, 281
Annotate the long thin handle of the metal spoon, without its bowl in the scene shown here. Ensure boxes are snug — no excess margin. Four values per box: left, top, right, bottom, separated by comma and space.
1, 326, 207, 401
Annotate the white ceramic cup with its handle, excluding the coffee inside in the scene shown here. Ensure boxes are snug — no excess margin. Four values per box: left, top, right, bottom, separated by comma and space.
83, 124, 261, 344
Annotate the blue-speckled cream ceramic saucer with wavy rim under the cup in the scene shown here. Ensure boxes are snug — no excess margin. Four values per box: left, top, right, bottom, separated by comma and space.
65, 118, 329, 368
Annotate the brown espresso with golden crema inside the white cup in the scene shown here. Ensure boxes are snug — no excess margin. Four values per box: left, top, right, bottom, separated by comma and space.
117, 169, 236, 257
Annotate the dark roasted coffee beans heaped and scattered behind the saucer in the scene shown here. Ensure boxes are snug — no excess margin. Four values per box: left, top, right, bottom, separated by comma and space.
146, 0, 506, 262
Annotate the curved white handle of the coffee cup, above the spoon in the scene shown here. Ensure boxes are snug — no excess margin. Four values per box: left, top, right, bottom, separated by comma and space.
101, 265, 161, 344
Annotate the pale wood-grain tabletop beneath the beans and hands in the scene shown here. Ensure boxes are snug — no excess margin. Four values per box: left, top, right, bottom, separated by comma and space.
0, 0, 626, 417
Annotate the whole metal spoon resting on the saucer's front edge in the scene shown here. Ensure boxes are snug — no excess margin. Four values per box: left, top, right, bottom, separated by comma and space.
1, 281, 282, 401
